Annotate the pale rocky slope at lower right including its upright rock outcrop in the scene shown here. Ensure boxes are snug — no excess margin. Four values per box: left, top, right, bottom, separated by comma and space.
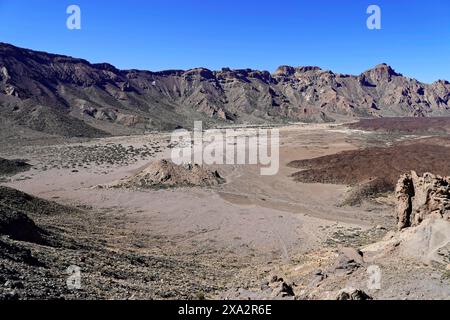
223, 172, 450, 300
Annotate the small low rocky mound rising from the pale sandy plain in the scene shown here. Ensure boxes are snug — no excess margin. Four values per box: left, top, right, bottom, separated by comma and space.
109, 160, 225, 189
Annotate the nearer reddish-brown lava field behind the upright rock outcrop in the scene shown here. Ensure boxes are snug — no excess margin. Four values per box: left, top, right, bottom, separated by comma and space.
289, 137, 450, 192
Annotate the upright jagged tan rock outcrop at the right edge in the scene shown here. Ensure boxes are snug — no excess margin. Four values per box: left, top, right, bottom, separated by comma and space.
395, 171, 450, 230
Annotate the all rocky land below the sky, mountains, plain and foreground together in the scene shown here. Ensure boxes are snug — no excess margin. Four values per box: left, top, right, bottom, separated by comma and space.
0, 44, 450, 300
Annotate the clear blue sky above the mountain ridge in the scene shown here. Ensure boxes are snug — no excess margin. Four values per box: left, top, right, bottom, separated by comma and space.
0, 0, 450, 82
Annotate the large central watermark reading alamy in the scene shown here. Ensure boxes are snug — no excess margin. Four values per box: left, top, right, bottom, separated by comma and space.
171, 121, 280, 175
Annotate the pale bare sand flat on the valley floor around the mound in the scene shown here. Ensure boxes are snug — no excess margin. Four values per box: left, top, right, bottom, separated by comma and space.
3, 121, 381, 261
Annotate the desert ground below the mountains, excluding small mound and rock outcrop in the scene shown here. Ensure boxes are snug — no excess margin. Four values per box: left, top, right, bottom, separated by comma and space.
0, 121, 450, 299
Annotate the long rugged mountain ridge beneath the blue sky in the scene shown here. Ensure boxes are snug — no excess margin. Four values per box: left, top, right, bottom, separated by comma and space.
0, 43, 450, 136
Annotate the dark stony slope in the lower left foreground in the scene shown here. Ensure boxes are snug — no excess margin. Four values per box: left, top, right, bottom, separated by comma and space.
0, 187, 246, 300
